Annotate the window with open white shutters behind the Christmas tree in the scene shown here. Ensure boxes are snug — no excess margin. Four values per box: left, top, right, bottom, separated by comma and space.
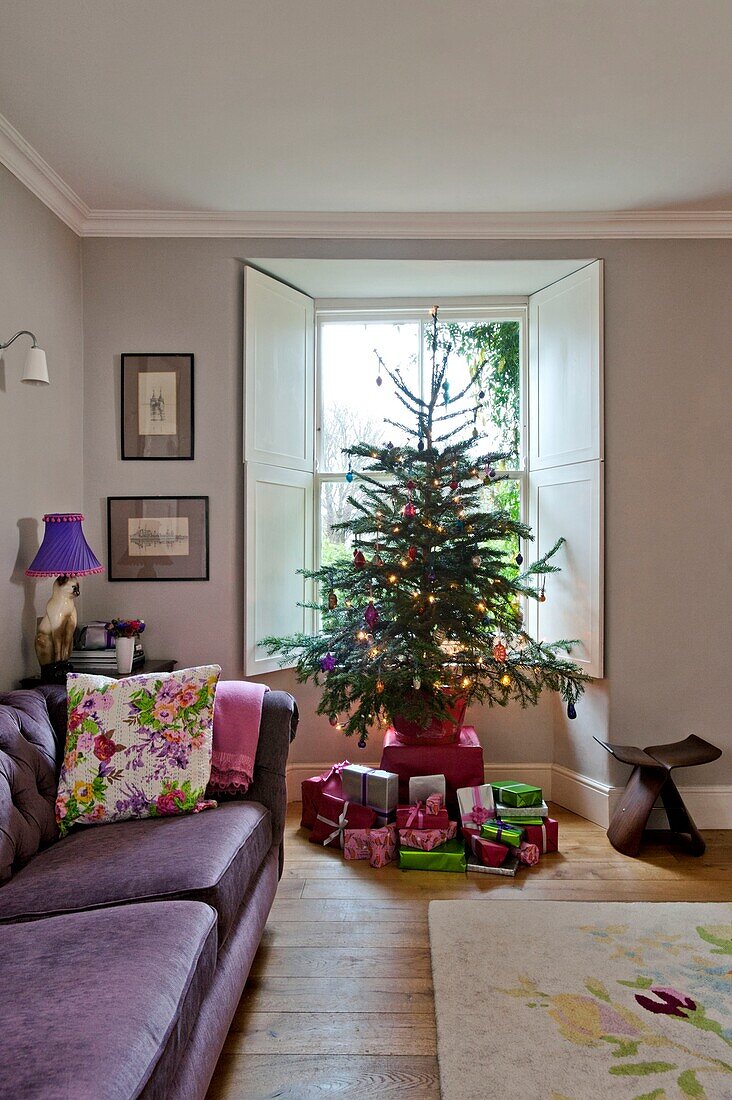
243, 261, 603, 677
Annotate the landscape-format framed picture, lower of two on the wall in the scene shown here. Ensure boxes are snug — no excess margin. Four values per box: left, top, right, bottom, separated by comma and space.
107, 496, 208, 581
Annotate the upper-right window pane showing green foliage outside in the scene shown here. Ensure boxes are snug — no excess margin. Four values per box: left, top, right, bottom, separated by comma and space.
425, 321, 521, 469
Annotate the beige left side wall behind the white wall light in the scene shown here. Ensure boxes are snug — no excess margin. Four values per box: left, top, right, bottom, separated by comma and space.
0, 167, 83, 688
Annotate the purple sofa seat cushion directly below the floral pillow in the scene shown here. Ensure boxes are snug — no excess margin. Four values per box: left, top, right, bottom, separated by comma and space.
0, 802, 272, 946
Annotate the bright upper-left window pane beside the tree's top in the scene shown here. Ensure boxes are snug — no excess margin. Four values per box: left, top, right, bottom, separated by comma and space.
319, 321, 419, 473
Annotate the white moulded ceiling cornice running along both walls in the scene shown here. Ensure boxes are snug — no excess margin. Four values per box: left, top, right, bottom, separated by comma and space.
0, 114, 732, 241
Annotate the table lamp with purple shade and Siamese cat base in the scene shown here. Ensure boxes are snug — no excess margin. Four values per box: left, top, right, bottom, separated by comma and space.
25, 513, 103, 683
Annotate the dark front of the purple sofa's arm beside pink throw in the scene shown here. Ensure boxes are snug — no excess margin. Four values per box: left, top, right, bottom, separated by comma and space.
238, 691, 298, 845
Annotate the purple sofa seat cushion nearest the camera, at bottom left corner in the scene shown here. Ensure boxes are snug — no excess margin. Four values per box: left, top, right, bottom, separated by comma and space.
0, 902, 216, 1100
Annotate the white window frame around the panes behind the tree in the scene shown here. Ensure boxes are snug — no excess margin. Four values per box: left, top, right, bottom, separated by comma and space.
313, 296, 529, 585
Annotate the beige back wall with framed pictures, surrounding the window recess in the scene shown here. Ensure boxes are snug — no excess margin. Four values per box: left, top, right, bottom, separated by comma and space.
84, 239, 732, 784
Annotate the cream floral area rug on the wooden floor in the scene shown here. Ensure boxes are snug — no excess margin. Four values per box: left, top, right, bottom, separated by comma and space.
429, 901, 732, 1100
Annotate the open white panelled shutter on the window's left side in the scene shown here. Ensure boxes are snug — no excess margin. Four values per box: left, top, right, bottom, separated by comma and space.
243, 267, 315, 675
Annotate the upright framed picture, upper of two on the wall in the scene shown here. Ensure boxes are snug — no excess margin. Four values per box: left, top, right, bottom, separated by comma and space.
122, 352, 194, 461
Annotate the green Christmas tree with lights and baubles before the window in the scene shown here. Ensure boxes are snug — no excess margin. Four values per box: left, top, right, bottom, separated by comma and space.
263, 307, 589, 747
